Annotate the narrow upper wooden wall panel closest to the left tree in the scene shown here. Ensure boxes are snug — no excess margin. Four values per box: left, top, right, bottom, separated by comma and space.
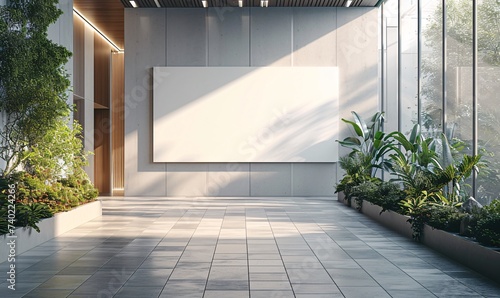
73, 15, 85, 98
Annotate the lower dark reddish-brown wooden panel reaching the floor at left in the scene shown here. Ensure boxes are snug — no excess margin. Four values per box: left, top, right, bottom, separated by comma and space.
94, 109, 111, 196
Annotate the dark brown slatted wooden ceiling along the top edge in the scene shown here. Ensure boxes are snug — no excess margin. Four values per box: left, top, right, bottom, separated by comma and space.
73, 0, 382, 49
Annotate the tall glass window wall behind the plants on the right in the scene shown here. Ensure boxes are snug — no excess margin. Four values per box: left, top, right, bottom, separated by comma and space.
381, 0, 500, 203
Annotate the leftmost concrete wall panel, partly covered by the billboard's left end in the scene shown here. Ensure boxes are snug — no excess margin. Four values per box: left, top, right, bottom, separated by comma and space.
125, 9, 166, 196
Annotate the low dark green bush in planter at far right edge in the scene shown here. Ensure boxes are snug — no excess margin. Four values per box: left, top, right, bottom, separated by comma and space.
473, 199, 500, 247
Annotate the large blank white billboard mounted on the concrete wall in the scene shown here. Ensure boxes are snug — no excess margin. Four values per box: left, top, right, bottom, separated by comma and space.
153, 67, 338, 162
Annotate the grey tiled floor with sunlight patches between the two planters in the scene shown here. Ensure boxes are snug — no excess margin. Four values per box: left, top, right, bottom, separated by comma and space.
0, 198, 500, 298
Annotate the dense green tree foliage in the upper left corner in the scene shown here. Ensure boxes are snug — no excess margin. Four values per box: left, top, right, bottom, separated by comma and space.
0, 0, 71, 175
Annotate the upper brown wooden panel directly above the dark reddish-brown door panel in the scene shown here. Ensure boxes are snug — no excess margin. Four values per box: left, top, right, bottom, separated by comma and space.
94, 33, 111, 108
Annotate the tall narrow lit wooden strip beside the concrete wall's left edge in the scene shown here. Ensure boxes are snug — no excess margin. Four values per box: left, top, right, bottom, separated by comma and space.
111, 53, 125, 196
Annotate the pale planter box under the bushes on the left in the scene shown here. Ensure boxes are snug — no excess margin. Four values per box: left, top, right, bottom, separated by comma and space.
0, 201, 102, 263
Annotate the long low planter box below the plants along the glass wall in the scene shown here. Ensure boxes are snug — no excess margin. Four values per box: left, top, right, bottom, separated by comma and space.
339, 200, 500, 283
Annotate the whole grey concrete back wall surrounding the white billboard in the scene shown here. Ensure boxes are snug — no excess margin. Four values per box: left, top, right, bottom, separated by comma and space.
125, 7, 378, 196
